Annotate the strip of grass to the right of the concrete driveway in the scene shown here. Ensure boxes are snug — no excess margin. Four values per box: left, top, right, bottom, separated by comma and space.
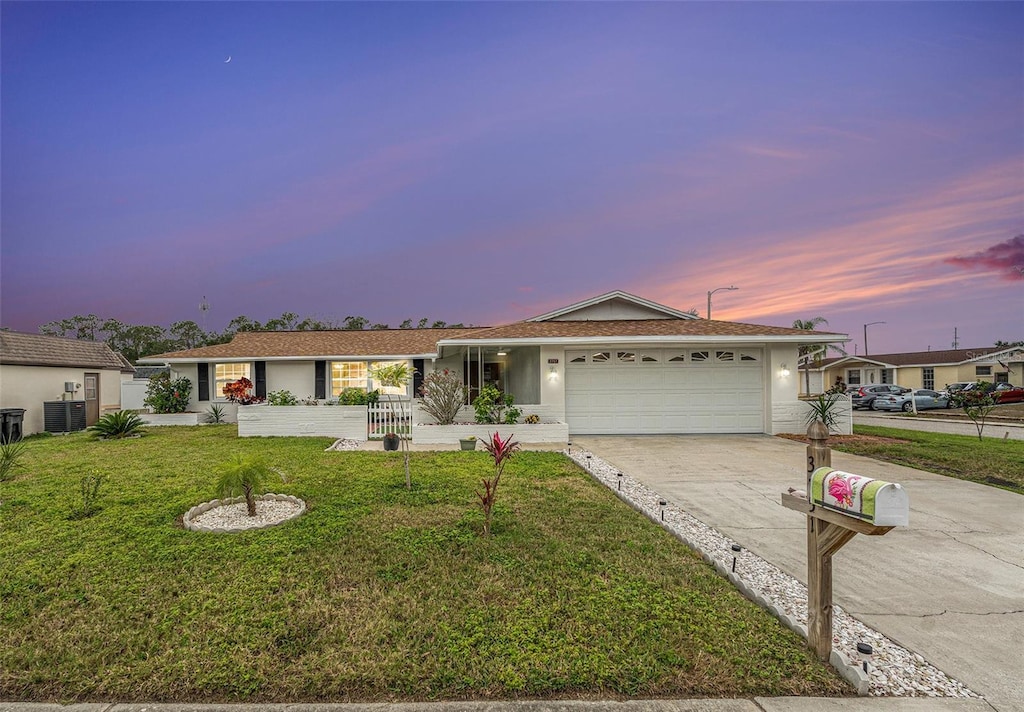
829, 425, 1024, 494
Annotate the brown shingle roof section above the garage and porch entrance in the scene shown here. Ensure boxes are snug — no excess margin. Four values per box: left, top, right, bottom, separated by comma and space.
438, 319, 844, 341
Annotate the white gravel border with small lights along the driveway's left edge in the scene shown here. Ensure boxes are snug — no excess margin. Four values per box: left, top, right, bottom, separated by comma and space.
562, 449, 980, 699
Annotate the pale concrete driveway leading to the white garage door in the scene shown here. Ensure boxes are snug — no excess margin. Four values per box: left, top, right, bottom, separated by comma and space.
572, 435, 1024, 712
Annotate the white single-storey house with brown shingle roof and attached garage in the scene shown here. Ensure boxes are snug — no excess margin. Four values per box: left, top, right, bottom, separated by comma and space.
140, 292, 847, 434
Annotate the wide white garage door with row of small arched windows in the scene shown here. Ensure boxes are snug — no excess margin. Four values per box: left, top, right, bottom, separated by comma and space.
565, 348, 765, 434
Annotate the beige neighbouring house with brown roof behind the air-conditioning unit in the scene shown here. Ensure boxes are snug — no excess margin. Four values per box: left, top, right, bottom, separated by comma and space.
0, 331, 134, 435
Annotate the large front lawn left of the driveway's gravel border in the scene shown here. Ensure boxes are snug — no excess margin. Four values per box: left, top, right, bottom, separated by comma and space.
0, 426, 850, 702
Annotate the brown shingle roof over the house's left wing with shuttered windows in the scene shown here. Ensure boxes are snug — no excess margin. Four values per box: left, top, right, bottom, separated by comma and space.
141, 329, 487, 362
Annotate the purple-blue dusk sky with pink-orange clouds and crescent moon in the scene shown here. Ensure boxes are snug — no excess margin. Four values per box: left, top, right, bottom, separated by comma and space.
0, 2, 1024, 353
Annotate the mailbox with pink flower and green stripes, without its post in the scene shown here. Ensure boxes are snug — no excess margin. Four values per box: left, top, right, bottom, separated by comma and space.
808, 467, 910, 527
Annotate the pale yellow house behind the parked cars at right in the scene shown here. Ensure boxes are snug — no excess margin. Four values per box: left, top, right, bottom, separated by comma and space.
811, 346, 1024, 390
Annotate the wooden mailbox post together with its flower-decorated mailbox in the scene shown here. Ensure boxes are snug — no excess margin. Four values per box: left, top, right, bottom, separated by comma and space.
782, 467, 909, 661
